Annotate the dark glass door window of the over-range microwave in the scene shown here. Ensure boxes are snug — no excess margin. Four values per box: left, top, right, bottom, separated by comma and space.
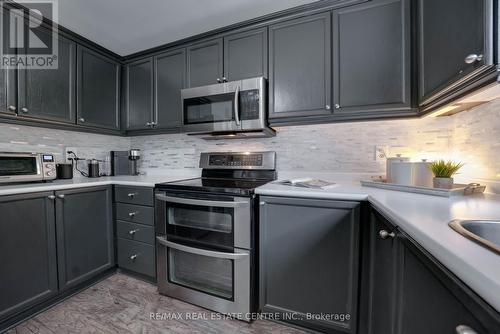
184, 93, 234, 124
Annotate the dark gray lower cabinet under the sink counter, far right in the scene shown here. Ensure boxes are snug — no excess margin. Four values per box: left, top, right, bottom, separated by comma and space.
360, 212, 500, 334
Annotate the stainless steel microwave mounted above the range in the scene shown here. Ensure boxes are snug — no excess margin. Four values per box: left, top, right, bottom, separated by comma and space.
181, 77, 275, 139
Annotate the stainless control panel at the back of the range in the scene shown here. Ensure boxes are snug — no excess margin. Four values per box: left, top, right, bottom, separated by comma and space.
200, 152, 276, 170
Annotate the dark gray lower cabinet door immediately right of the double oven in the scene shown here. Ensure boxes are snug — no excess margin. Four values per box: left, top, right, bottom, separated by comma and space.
259, 197, 359, 333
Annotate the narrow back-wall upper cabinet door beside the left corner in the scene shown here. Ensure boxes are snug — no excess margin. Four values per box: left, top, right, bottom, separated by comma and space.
125, 58, 153, 130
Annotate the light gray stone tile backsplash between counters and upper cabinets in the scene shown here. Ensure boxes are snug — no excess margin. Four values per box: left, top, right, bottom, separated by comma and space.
0, 100, 500, 180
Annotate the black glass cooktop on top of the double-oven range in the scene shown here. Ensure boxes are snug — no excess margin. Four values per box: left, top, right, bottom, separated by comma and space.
156, 177, 271, 195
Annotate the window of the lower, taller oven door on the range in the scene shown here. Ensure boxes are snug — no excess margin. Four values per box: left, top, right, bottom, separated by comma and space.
167, 248, 233, 300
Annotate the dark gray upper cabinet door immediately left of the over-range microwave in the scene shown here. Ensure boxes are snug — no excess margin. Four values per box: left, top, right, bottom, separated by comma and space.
154, 49, 186, 129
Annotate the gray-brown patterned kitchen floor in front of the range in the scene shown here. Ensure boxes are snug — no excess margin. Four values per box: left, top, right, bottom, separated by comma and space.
7, 273, 304, 334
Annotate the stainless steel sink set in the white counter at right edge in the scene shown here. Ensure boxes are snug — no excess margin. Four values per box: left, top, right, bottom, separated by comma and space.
448, 219, 500, 254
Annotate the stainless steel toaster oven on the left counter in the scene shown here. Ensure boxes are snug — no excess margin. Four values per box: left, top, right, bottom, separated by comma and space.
0, 152, 57, 183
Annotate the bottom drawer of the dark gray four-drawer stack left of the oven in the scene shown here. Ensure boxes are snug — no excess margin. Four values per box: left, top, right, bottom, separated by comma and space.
118, 238, 156, 277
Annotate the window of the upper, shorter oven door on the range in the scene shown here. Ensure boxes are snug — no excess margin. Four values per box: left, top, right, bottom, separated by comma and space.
167, 203, 234, 234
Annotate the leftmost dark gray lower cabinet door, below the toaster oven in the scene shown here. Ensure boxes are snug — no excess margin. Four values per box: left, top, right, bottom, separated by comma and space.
0, 192, 57, 323
